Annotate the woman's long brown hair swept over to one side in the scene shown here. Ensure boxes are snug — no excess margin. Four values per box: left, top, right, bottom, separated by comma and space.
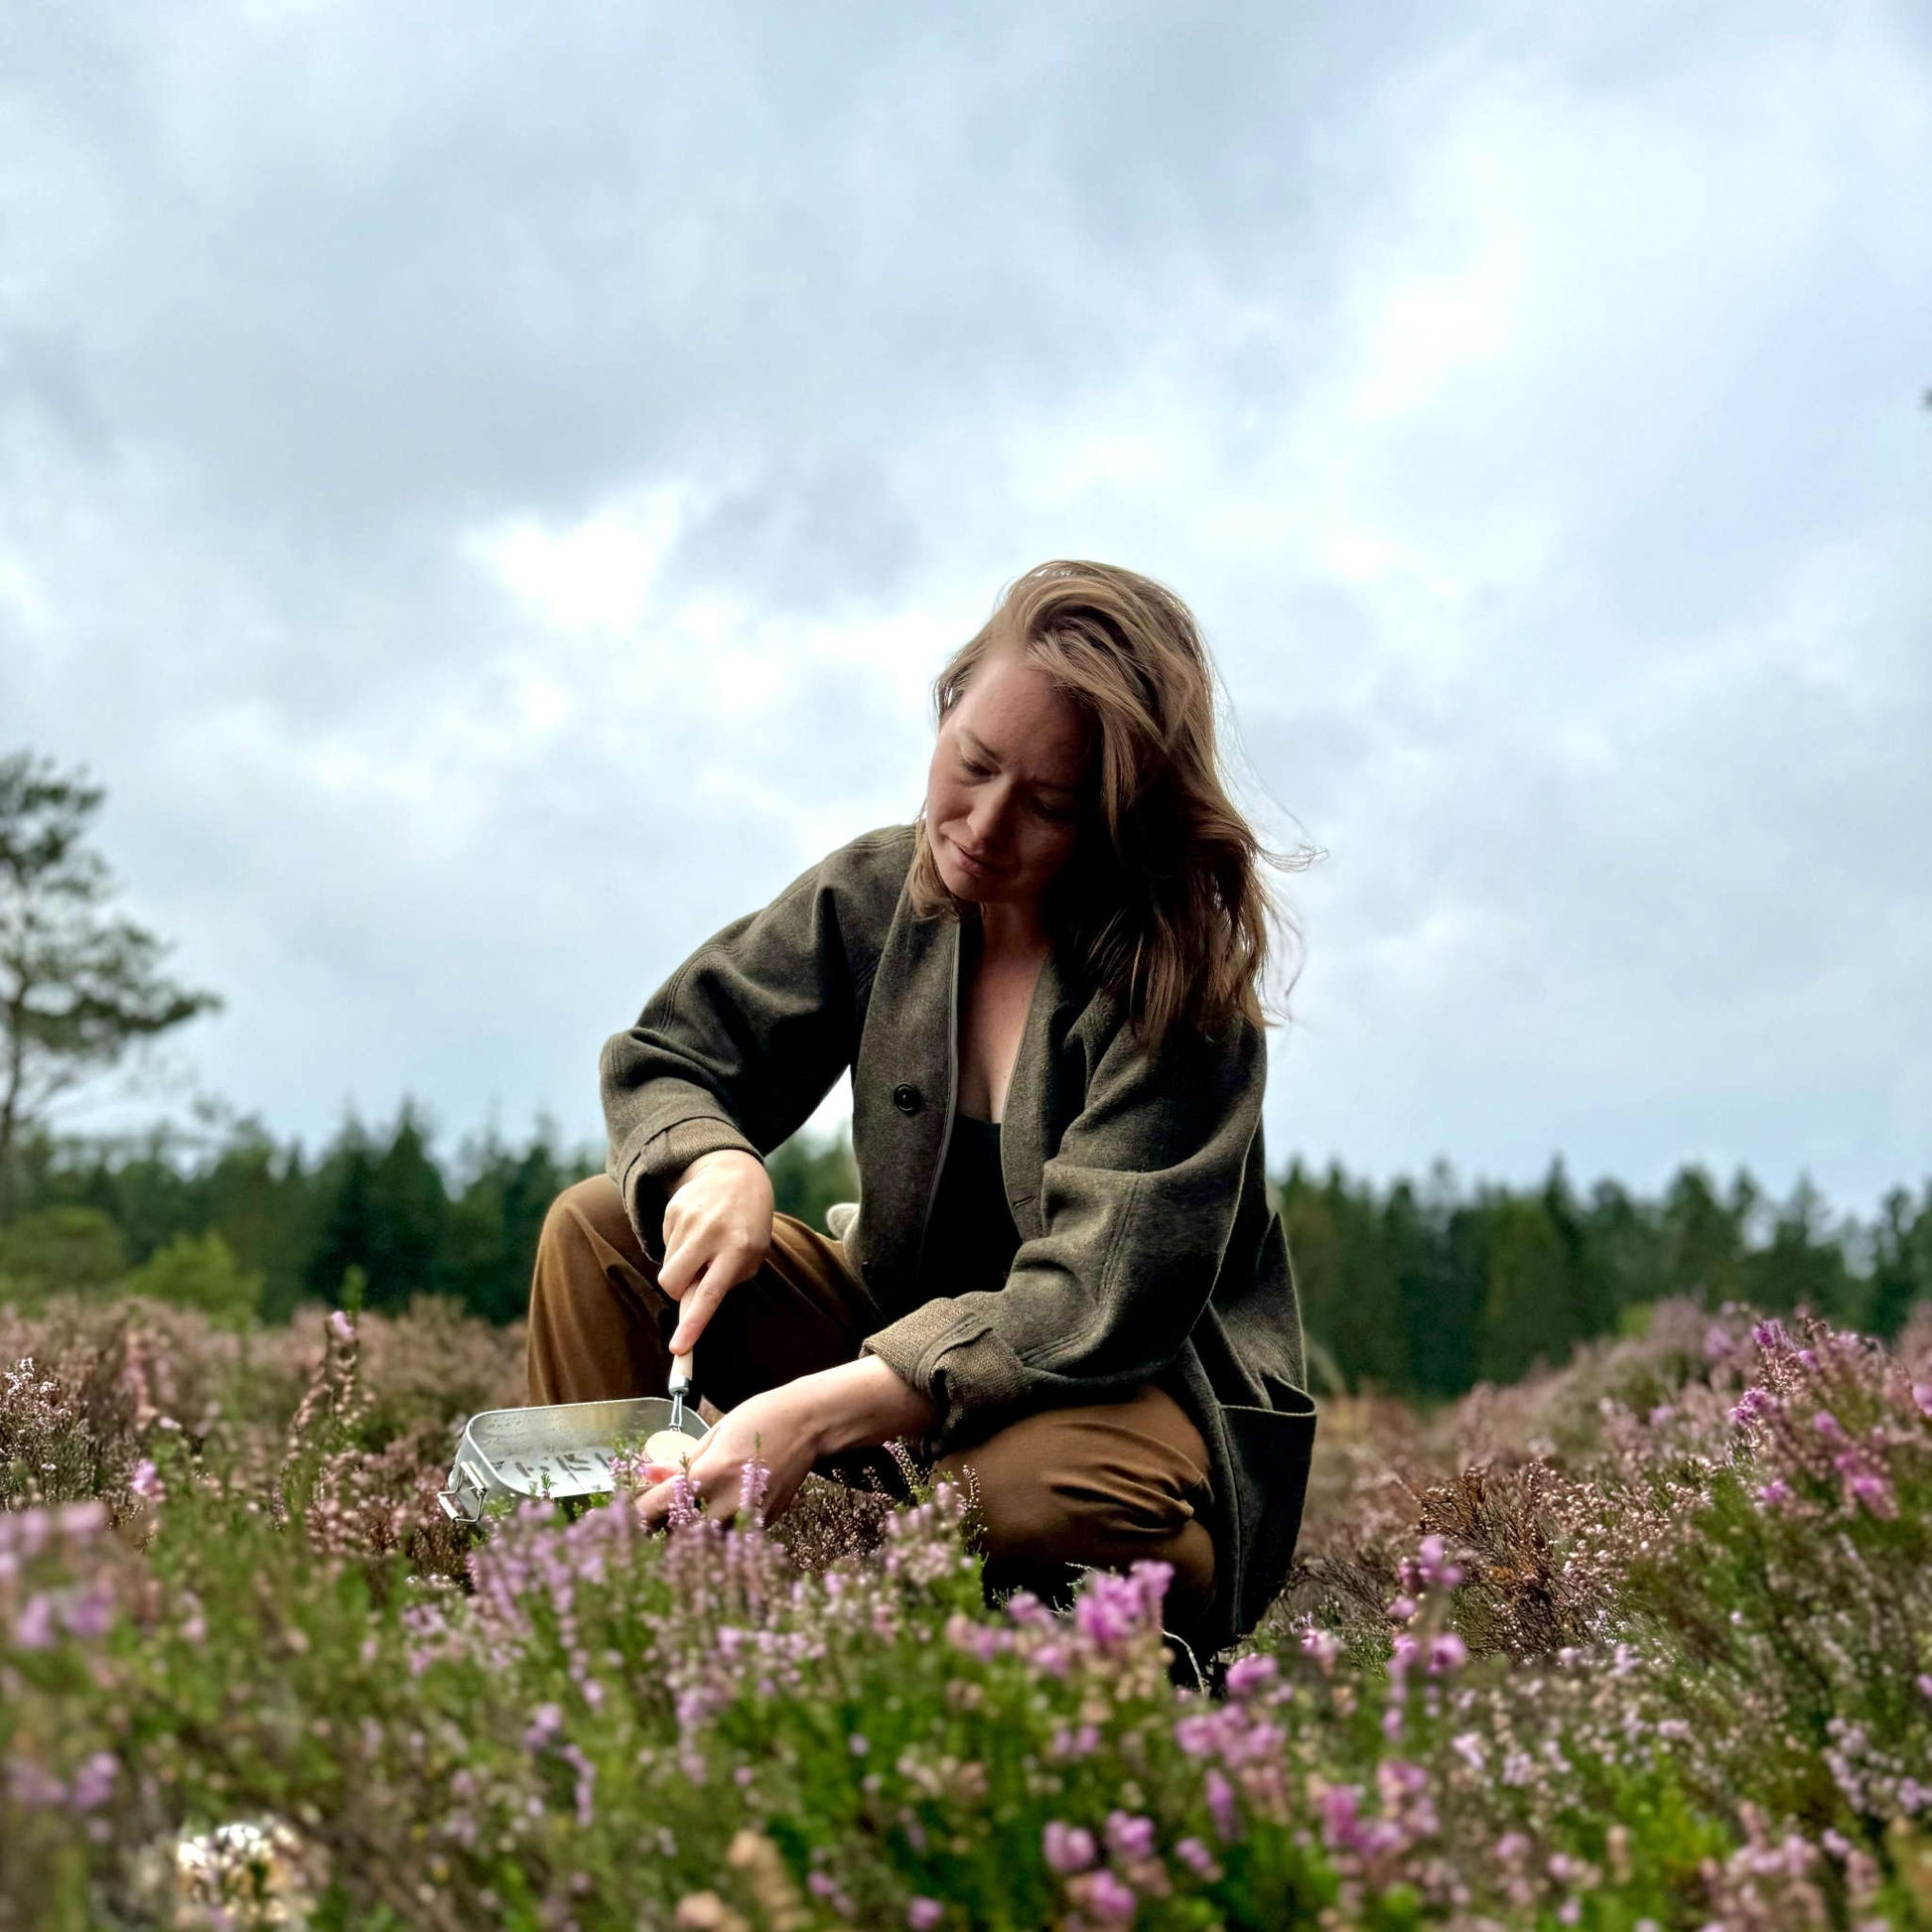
910, 560, 1293, 1049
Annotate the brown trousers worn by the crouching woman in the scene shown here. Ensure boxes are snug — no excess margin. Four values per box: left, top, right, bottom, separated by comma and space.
529, 1174, 1215, 1630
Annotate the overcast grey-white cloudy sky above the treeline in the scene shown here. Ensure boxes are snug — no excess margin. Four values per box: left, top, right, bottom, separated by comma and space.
0, 0, 1932, 1211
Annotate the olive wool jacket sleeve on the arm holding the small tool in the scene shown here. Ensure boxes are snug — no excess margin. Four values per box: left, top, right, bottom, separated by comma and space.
599, 837, 881, 1260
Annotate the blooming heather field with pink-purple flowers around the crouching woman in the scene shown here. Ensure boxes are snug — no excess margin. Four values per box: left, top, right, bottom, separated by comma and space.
0, 1301, 1932, 1932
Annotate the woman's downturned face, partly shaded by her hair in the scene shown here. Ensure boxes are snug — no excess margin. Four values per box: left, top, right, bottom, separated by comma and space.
925, 645, 1091, 906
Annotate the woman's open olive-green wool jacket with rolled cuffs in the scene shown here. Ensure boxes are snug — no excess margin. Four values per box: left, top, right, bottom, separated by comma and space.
601, 825, 1315, 1648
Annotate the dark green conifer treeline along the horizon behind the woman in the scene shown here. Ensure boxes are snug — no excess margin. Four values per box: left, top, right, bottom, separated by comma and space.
0, 1105, 1932, 1401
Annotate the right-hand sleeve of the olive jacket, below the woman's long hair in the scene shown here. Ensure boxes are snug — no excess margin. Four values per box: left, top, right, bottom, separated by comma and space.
864, 1020, 1268, 1454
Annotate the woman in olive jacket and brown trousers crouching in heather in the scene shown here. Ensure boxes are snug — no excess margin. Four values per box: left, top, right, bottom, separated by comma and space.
529, 562, 1313, 1648
